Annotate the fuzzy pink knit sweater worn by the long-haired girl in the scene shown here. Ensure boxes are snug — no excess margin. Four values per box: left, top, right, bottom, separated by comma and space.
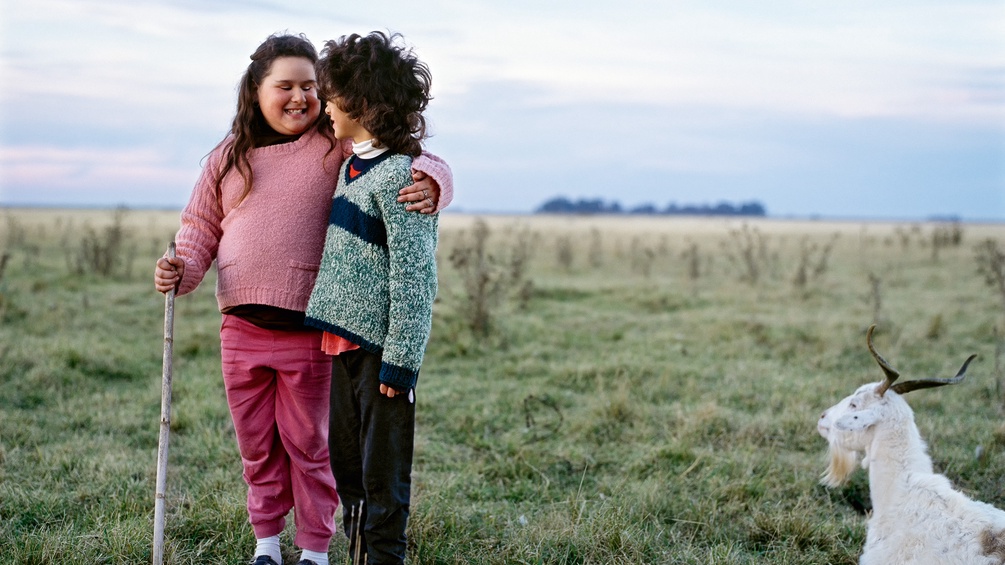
175, 130, 453, 312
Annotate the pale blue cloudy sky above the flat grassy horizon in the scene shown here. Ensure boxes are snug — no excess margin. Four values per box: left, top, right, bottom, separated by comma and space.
0, 0, 1005, 222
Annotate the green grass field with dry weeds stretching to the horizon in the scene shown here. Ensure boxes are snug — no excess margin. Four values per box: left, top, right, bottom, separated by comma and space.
0, 209, 1005, 565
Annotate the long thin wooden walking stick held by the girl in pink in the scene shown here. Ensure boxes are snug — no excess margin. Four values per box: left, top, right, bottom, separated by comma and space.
154, 241, 175, 565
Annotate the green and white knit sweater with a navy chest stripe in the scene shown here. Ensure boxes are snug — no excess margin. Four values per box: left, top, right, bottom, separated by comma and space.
306, 153, 439, 390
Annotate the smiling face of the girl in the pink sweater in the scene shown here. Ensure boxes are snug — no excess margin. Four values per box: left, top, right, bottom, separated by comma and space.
256, 57, 321, 136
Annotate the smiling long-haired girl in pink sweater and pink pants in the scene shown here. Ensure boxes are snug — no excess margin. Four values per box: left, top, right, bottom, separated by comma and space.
154, 31, 452, 565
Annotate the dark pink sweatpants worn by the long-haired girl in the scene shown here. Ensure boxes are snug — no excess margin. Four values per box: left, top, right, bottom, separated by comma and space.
220, 315, 339, 552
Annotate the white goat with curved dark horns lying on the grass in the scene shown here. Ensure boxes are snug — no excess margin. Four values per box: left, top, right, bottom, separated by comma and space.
817, 326, 1005, 565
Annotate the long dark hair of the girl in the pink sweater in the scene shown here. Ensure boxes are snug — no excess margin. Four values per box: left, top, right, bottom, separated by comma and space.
216, 33, 336, 206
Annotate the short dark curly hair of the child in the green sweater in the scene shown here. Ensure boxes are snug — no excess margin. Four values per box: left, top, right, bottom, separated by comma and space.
317, 31, 432, 157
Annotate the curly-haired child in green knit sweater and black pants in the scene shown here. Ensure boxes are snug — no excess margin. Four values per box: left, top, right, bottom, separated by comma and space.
306, 32, 438, 564
